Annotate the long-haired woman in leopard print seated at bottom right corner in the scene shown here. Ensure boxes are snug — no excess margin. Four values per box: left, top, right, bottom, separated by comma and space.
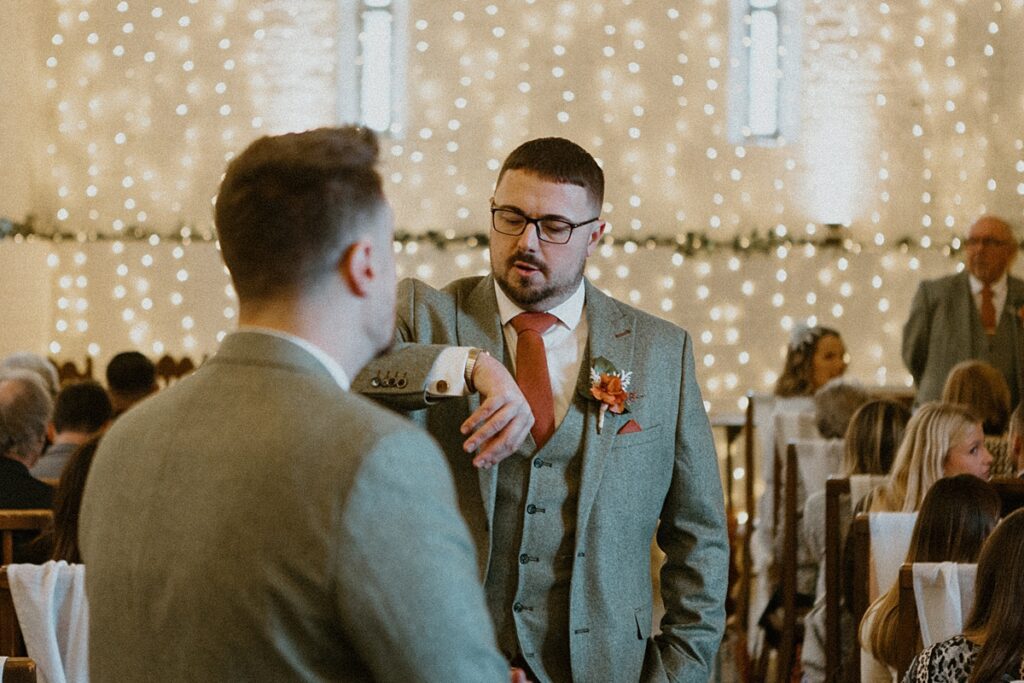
903, 510, 1024, 683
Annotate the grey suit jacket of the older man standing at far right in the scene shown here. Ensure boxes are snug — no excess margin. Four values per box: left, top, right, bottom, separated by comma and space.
903, 270, 1024, 405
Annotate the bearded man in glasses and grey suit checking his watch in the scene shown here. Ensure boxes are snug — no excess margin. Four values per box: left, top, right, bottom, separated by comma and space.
356, 138, 728, 683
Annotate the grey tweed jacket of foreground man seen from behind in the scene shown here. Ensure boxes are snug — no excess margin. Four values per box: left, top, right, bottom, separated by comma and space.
80, 332, 508, 683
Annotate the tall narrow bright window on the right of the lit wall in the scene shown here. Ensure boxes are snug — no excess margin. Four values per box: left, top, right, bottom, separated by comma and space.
728, 0, 802, 145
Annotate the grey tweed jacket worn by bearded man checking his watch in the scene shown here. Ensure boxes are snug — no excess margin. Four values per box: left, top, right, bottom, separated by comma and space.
354, 276, 728, 683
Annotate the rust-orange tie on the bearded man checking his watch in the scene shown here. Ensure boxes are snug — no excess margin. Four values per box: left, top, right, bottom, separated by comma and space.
511, 313, 558, 449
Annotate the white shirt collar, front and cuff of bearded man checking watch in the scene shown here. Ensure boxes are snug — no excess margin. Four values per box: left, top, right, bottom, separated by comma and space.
427, 280, 589, 426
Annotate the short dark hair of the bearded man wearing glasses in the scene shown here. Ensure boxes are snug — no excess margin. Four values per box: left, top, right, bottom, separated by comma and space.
498, 137, 604, 210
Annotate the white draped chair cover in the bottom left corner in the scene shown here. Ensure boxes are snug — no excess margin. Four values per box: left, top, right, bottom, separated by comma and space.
7, 560, 89, 683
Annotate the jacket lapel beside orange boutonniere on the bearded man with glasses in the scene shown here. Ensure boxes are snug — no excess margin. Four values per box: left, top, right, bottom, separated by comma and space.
577, 281, 636, 529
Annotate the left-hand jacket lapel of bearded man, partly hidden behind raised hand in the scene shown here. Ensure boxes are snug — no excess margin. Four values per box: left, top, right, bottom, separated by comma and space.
455, 275, 505, 528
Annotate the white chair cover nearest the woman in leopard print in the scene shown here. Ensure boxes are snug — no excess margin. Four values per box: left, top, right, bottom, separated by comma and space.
913, 562, 978, 647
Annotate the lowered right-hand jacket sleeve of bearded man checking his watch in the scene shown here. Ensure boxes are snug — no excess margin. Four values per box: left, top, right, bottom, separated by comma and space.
642, 333, 729, 683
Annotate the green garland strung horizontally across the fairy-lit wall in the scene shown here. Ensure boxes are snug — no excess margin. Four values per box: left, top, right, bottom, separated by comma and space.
0, 215, 995, 256
